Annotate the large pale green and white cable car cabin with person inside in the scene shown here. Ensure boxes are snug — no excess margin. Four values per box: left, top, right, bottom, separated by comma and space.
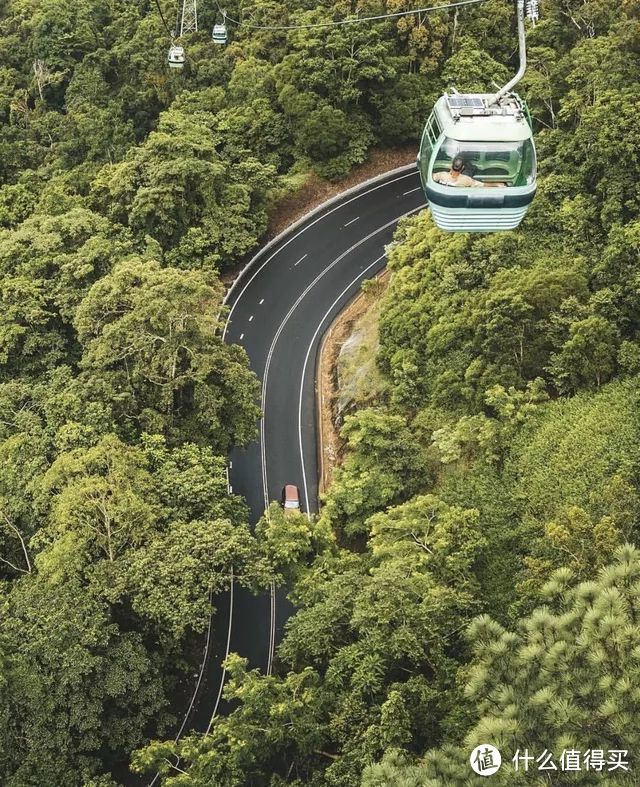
418, 93, 536, 232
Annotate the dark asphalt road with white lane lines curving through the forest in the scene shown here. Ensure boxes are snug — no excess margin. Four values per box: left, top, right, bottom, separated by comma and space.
225, 163, 425, 673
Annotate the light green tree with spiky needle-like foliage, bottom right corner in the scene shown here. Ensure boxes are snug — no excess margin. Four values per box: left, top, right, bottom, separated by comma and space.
363, 545, 640, 785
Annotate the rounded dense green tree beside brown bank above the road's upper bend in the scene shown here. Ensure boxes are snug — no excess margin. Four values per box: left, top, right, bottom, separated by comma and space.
93, 110, 274, 269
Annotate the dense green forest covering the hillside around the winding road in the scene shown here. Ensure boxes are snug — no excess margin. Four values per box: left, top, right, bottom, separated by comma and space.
0, 0, 640, 787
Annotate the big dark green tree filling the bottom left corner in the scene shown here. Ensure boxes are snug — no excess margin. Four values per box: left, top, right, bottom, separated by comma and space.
0, 565, 165, 787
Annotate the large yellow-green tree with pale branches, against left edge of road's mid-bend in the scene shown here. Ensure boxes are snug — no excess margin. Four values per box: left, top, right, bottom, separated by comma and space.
75, 258, 258, 451
